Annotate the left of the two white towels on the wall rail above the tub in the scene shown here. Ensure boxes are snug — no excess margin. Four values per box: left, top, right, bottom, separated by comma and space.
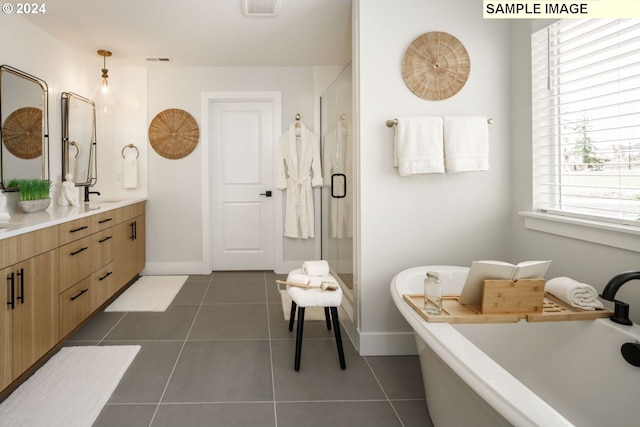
393, 116, 444, 176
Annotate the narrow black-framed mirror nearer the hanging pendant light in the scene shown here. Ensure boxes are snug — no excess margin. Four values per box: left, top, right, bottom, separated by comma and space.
61, 92, 97, 187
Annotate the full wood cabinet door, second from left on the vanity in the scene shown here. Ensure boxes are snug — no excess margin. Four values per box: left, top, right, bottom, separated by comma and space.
12, 251, 59, 377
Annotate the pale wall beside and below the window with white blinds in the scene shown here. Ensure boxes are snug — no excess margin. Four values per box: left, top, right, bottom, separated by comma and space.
511, 20, 640, 323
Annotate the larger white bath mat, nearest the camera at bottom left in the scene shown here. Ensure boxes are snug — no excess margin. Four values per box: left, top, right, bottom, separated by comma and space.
0, 345, 140, 427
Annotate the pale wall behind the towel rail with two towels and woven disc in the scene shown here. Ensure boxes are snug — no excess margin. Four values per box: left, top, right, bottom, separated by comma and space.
354, 0, 511, 354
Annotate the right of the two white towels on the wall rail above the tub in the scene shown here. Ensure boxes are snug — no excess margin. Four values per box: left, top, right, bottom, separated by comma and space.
444, 116, 489, 172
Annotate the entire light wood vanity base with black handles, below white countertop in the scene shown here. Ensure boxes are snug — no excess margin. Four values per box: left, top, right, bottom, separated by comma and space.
0, 202, 145, 391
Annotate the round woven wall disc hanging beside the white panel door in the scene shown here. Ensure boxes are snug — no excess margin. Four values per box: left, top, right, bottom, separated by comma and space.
149, 108, 200, 159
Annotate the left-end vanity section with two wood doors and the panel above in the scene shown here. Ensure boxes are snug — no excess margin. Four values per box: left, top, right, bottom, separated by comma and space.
0, 231, 60, 388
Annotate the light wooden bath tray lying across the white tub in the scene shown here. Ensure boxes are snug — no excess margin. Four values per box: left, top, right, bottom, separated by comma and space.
402, 293, 613, 323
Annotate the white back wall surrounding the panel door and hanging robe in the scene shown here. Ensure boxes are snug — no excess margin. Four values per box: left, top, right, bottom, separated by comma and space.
145, 65, 328, 274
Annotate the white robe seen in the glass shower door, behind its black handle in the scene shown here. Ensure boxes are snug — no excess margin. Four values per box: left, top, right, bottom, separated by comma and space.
322, 121, 353, 239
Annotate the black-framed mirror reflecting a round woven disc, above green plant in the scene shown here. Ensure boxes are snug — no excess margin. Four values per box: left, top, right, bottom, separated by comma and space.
0, 65, 49, 190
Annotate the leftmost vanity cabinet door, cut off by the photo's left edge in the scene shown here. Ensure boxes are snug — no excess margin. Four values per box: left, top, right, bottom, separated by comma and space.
0, 268, 15, 390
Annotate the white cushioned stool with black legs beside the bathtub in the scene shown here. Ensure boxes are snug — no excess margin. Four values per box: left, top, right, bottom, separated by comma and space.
287, 270, 346, 371
